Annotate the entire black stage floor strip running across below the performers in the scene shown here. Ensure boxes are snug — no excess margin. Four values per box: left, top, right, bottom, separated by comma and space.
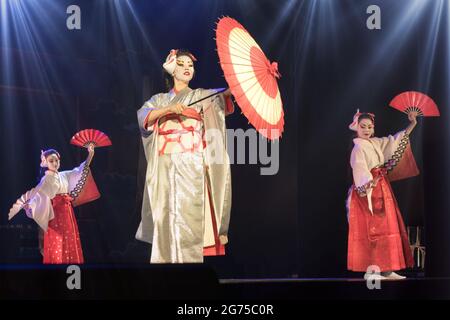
0, 265, 450, 301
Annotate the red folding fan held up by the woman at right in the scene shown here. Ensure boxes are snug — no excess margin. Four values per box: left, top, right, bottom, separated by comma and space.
389, 91, 440, 117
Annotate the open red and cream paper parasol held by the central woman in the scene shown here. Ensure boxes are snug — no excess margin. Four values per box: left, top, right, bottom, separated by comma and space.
216, 17, 284, 140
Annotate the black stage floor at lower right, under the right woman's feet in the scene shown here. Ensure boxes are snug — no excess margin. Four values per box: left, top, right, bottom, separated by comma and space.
219, 278, 450, 300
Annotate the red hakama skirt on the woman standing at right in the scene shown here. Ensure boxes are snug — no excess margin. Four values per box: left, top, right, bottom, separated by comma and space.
347, 168, 414, 272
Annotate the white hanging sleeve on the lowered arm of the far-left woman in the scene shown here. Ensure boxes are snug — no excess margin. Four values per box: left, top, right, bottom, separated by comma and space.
27, 171, 60, 231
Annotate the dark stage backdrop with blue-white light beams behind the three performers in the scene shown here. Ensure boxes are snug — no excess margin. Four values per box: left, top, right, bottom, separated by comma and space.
0, 0, 450, 278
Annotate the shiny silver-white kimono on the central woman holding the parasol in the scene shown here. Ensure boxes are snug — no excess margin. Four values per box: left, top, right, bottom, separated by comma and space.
136, 88, 231, 263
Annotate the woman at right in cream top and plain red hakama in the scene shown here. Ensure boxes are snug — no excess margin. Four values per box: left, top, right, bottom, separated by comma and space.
347, 110, 418, 279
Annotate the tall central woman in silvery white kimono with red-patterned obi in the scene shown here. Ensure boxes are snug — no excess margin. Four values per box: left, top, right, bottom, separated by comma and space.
136, 50, 233, 263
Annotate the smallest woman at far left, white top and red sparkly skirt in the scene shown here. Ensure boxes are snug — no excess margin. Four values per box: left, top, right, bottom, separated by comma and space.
9, 145, 100, 264
